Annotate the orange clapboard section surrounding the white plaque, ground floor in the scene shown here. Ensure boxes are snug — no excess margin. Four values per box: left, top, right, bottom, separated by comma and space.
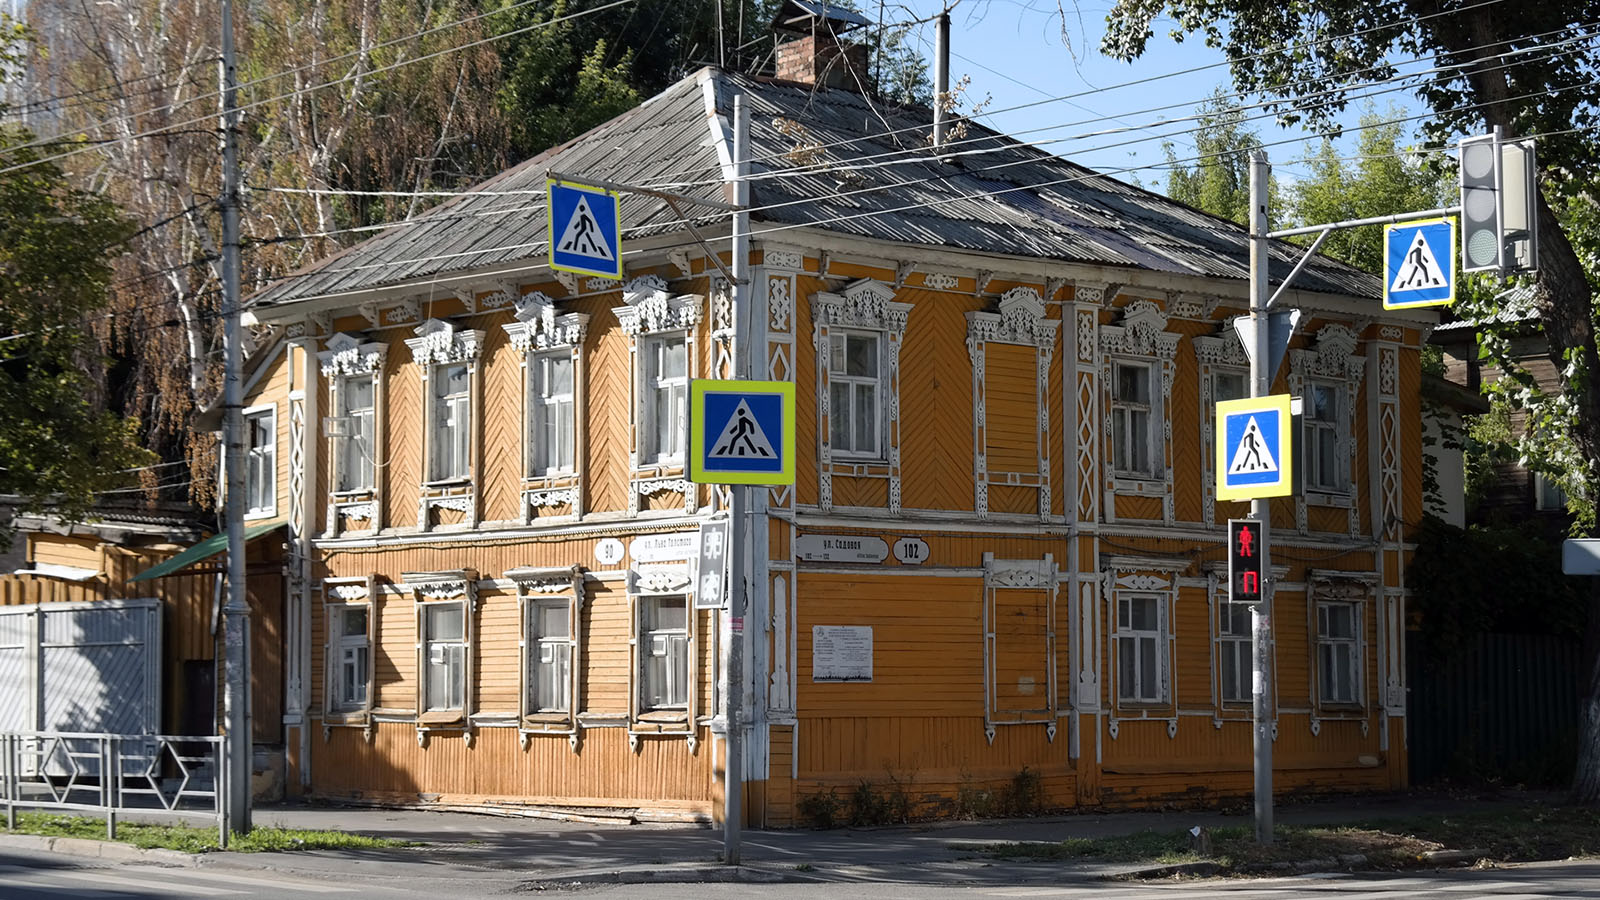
795, 570, 984, 714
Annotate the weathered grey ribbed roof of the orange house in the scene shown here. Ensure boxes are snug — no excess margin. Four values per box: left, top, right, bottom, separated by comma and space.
250, 69, 1381, 309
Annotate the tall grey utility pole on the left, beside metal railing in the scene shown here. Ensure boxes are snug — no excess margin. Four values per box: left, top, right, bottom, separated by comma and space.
219, 0, 251, 833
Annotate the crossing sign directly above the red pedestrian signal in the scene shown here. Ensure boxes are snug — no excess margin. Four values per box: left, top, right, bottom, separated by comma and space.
1216, 394, 1294, 500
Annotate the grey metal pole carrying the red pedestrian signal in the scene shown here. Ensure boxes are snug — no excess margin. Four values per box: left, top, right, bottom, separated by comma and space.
1250, 151, 1274, 844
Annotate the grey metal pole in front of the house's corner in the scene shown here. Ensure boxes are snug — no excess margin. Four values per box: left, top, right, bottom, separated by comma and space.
722, 94, 755, 866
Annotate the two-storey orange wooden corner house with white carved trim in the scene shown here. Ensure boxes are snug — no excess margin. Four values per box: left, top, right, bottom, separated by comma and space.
246, 42, 1432, 826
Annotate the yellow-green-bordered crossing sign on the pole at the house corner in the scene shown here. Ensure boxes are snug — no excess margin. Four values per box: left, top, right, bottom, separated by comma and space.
690, 378, 795, 484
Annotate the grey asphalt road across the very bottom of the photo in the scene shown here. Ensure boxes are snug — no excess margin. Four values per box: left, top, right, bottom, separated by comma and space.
0, 852, 1600, 900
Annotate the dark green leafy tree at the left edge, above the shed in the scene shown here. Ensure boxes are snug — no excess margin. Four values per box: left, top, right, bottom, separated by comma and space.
0, 118, 152, 534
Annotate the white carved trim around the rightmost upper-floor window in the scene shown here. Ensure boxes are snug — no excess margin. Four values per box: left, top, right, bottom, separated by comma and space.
1290, 322, 1366, 536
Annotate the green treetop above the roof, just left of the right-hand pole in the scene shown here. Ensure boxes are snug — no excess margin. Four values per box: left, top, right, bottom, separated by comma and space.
1162, 88, 1282, 226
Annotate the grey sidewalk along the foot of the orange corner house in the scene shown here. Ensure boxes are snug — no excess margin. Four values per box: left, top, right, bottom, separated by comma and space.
0, 793, 1554, 886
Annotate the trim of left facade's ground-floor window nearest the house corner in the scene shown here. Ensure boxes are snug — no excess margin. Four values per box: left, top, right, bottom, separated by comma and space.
627, 562, 701, 753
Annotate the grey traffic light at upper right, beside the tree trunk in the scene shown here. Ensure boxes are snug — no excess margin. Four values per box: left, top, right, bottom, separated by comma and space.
1459, 128, 1539, 274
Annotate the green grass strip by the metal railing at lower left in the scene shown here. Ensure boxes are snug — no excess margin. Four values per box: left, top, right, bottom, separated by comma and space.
14, 812, 414, 854
